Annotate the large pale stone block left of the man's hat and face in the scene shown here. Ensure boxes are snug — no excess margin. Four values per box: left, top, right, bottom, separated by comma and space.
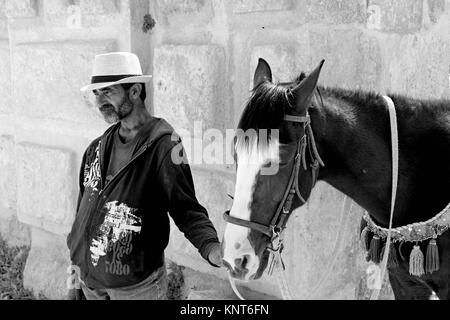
12, 40, 116, 123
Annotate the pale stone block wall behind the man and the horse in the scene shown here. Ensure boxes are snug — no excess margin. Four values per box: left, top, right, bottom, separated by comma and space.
0, 0, 450, 299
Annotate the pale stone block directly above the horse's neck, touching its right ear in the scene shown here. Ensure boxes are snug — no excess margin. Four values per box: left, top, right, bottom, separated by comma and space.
309, 29, 383, 91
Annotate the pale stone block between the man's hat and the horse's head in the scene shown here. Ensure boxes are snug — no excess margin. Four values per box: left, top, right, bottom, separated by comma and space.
153, 45, 227, 132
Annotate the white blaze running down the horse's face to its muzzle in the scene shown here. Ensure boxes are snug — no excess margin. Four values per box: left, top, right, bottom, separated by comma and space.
224, 139, 279, 280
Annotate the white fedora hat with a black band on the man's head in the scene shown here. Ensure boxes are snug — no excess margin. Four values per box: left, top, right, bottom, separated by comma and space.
81, 52, 152, 92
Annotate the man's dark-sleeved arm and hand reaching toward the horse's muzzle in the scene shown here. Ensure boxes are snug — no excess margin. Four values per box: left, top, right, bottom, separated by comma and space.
158, 141, 222, 267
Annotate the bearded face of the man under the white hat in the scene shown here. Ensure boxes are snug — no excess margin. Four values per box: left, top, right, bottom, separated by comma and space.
93, 85, 133, 124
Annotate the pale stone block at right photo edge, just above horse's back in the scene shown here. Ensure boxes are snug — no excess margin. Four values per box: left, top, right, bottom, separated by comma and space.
389, 33, 450, 99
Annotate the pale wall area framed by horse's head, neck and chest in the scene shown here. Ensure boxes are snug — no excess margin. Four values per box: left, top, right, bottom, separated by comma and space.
284, 182, 394, 299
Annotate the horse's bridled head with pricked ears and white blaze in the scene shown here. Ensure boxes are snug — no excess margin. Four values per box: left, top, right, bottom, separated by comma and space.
223, 59, 324, 280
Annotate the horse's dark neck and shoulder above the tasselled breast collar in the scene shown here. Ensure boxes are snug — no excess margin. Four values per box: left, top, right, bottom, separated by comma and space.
312, 89, 450, 226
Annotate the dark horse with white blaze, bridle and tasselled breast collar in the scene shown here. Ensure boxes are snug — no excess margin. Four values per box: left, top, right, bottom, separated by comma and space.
222, 59, 450, 300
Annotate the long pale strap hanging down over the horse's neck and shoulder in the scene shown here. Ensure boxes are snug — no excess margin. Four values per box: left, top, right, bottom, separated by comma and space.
370, 96, 398, 300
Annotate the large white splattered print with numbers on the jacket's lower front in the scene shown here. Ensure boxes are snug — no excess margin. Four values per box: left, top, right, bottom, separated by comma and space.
90, 201, 142, 275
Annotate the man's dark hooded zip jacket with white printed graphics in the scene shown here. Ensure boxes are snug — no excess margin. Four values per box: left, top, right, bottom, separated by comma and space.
67, 118, 218, 288
